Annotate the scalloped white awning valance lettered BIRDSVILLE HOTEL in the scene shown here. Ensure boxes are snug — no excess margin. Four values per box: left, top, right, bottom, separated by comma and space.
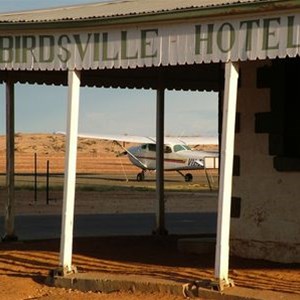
0, 14, 300, 70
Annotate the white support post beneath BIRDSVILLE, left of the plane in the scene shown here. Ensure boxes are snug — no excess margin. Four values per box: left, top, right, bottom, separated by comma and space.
60, 70, 80, 274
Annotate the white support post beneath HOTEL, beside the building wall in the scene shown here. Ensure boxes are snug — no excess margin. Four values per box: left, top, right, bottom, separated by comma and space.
215, 62, 239, 289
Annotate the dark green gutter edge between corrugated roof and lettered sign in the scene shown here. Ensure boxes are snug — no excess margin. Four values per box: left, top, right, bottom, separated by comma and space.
0, 0, 300, 31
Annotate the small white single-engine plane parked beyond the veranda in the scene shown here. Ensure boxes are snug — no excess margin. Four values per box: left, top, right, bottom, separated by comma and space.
78, 134, 219, 182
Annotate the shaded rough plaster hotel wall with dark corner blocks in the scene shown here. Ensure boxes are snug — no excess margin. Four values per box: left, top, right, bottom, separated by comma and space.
230, 61, 300, 262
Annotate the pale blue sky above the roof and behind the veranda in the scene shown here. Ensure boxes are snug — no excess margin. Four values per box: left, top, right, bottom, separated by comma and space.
0, 0, 218, 136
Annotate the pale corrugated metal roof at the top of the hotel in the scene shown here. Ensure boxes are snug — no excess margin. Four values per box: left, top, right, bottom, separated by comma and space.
0, 0, 274, 23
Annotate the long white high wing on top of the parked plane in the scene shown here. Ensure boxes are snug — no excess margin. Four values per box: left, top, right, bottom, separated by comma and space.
58, 132, 218, 145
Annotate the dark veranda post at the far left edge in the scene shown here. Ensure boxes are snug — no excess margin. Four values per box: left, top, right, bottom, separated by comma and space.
3, 81, 17, 241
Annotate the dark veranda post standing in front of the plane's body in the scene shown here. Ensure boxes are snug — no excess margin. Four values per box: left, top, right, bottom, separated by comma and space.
154, 87, 167, 235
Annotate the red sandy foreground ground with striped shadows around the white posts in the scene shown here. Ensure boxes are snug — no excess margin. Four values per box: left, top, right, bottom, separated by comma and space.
0, 237, 300, 300
